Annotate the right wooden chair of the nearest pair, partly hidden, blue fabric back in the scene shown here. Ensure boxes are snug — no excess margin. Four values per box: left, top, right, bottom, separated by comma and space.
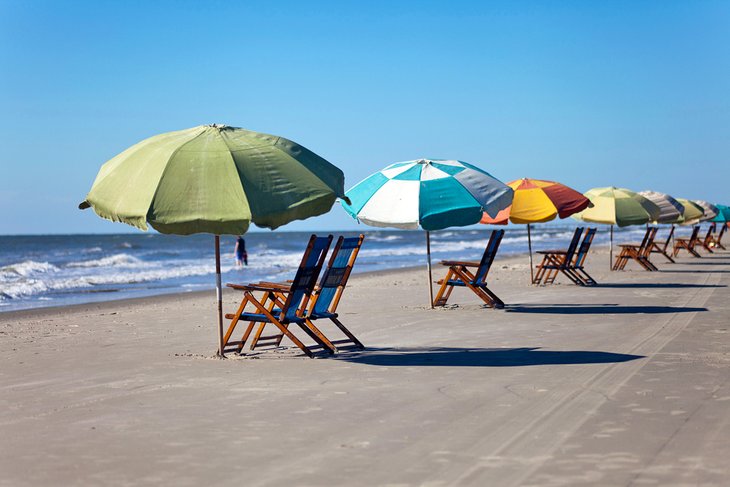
251, 235, 365, 351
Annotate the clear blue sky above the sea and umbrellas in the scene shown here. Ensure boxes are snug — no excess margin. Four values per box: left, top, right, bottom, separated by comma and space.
0, 0, 730, 234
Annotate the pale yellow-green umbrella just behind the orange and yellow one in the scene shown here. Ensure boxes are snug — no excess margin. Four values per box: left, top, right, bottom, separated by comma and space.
573, 186, 661, 266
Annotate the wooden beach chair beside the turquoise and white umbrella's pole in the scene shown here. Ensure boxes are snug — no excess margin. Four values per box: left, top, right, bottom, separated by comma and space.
433, 230, 504, 308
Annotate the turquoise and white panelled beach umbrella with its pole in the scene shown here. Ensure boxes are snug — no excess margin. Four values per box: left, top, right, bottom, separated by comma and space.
342, 159, 512, 307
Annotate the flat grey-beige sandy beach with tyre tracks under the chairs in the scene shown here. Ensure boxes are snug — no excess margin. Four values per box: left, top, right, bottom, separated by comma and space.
0, 252, 730, 486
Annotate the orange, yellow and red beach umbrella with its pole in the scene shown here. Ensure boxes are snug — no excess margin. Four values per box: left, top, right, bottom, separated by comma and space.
481, 178, 591, 282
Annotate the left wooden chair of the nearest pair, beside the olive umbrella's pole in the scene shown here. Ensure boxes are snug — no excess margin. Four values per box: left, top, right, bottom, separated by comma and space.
223, 235, 335, 358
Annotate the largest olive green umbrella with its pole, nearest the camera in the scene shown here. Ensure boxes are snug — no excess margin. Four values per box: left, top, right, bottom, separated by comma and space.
79, 125, 345, 356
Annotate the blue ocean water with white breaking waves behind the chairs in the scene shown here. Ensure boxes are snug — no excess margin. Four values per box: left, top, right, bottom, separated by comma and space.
0, 223, 672, 312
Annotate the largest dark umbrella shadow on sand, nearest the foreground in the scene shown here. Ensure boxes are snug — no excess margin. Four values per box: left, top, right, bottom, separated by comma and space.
335, 347, 644, 367
